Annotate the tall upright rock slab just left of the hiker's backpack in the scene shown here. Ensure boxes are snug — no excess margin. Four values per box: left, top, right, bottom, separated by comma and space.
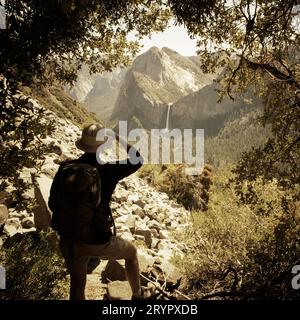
32, 175, 52, 231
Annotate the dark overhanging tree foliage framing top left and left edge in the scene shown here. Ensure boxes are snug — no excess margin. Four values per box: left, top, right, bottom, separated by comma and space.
0, 0, 169, 211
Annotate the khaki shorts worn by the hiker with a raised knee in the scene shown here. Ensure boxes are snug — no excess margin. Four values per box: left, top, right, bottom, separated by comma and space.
60, 236, 136, 267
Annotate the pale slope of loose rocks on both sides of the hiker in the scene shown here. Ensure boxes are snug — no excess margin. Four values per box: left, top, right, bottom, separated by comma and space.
0, 102, 189, 300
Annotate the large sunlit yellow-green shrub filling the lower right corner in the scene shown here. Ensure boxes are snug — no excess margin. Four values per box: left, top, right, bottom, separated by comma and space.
177, 175, 300, 299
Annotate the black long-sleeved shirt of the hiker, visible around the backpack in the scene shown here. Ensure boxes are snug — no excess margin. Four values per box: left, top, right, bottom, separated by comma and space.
48, 151, 142, 236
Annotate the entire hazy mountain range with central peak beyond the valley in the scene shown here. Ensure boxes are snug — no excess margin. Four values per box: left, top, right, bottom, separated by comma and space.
70, 47, 259, 135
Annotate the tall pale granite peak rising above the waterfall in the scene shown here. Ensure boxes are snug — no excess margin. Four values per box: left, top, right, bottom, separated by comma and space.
111, 47, 215, 128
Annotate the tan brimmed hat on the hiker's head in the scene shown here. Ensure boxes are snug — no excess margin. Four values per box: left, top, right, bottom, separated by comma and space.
75, 123, 104, 153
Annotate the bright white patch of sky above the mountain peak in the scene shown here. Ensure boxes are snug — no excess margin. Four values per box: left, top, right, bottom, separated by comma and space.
132, 26, 197, 56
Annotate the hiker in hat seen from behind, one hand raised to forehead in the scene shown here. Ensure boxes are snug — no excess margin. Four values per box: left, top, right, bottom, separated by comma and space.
49, 124, 142, 300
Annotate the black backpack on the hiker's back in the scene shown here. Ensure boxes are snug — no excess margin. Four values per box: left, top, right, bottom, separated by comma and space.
52, 162, 114, 243
